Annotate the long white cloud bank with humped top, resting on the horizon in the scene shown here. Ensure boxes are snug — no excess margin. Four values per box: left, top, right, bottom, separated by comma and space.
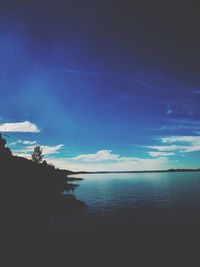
47, 150, 168, 171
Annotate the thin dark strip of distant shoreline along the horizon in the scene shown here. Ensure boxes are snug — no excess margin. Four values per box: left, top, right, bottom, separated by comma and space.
71, 169, 200, 174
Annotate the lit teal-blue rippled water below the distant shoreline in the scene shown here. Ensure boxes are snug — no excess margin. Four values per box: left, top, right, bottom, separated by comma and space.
68, 172, 200, 218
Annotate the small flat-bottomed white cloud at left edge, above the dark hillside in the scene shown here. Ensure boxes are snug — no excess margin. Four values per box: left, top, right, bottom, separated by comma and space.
0, 121, 40, 133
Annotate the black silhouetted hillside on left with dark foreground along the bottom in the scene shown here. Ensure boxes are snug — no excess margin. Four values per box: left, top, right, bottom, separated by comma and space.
0, 137, 200, 267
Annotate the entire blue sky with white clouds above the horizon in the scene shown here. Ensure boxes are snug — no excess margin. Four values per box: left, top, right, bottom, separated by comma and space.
0, 0, 200, 171
